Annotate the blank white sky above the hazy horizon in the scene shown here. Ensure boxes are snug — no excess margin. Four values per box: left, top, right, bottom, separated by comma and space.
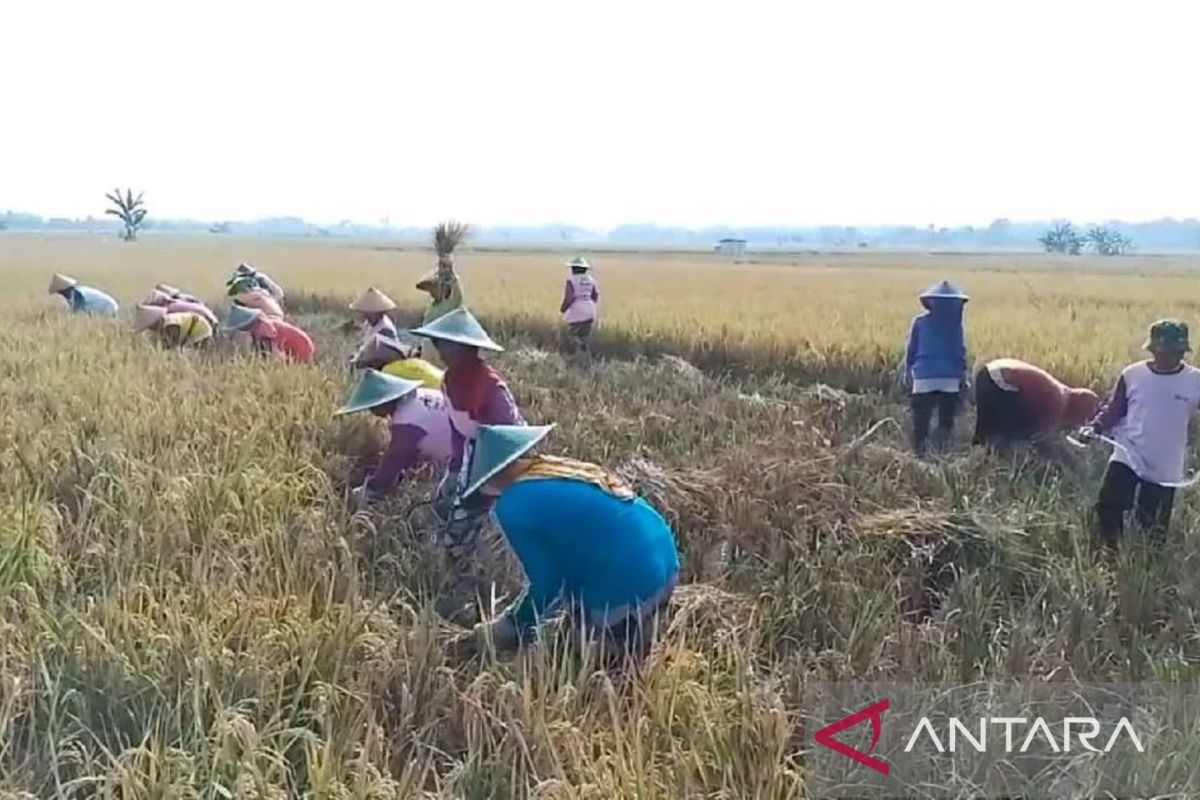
0, 0, 1200, 227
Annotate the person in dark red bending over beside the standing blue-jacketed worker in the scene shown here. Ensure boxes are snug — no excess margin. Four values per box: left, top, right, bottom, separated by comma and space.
974, 359, 1100, 445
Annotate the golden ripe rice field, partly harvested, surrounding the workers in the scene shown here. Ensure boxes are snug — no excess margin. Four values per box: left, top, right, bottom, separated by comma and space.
7, 234, 1200, 799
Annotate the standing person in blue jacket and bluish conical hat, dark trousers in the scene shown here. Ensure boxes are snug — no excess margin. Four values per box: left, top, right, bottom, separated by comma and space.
905, 281, 970, 457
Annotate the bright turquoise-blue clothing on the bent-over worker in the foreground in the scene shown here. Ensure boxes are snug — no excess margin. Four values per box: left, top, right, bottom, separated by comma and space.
494, 477, 679, 633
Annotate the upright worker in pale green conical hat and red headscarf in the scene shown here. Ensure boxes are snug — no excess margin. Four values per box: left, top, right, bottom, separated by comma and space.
412, 308, 524, 567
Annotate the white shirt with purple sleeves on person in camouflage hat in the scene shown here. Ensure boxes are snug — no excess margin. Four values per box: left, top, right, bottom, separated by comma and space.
1092, 361, 1200, 483
